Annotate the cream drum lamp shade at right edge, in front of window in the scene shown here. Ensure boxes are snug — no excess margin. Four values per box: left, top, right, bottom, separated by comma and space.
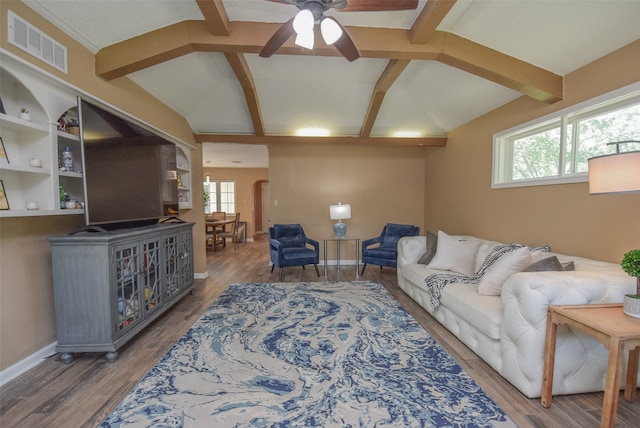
589, 152, 640, 195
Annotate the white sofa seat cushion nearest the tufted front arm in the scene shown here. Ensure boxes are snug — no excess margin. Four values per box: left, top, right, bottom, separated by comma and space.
440, 283, 502, 339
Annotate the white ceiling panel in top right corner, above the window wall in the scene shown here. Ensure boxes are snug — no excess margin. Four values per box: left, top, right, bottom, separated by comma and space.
440, 0, 640, 75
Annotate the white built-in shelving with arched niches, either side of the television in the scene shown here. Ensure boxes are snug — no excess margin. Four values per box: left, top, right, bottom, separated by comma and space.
0, 50, 193, 218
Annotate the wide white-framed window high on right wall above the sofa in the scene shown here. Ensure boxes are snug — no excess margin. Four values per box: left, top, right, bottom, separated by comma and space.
492, 82, 640, 188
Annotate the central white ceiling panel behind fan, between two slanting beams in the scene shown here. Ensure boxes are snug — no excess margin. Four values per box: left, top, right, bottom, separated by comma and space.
246, 55, 387, 135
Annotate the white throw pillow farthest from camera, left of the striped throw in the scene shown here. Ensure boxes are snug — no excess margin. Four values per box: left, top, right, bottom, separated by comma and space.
428, 230, 482, 276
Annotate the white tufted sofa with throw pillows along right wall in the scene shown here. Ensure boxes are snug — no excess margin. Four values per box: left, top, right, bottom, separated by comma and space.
397, 235, 640, 398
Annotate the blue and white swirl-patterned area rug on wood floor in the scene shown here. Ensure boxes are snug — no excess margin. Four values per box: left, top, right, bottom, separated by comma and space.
102, 281, 515, 427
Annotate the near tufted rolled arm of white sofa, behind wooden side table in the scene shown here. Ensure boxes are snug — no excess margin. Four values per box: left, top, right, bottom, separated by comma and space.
500, 269, 635, 398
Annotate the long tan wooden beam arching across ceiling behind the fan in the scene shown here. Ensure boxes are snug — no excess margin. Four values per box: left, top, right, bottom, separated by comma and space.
96, 21, 563, 103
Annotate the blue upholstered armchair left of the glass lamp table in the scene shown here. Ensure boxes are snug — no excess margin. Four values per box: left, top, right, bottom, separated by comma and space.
269, 224, 320, 281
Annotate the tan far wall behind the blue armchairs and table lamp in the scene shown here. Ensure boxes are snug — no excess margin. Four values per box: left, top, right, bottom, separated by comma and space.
269, 144, 425, 260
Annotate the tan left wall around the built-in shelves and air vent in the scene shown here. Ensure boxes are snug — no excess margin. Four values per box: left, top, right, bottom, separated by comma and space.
0, 0, 207, 370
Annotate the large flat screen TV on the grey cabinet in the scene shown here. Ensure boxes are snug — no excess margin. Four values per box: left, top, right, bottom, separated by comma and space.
78, 99, 178, 229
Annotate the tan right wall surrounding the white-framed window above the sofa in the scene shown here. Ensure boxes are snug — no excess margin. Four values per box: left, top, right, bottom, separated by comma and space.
424, 42, 640, 263
